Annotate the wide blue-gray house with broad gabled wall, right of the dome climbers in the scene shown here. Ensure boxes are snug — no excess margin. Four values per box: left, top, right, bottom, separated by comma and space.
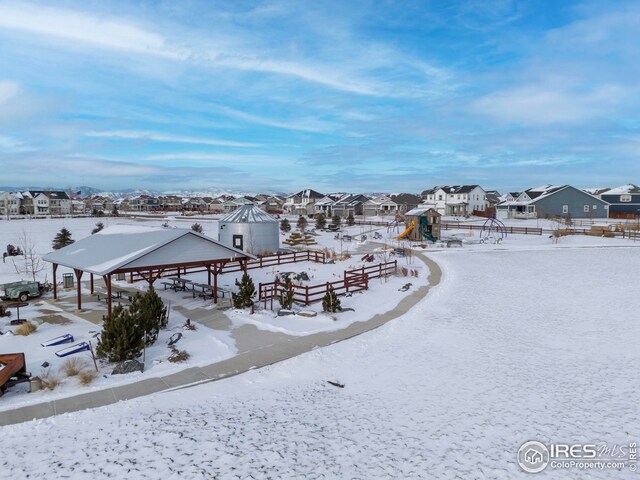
496, 185, 609, 218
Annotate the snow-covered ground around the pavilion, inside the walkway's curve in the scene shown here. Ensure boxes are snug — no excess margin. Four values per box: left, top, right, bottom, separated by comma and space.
0, 216, 427, 412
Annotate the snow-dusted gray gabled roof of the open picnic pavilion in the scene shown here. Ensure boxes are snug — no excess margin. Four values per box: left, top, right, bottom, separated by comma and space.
43, 225, 253, 275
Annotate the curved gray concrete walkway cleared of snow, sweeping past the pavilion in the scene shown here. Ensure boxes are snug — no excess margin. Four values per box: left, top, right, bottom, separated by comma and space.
0, 252, 442, 426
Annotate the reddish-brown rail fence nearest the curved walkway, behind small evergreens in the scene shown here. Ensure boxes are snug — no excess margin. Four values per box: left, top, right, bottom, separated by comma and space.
258, 260, 398, 309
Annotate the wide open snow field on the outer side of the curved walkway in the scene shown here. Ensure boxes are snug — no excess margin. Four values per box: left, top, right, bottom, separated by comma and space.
0, 232, 640, 479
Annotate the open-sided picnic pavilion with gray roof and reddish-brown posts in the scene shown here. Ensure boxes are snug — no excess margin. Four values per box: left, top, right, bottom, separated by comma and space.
43, 225, 255, 313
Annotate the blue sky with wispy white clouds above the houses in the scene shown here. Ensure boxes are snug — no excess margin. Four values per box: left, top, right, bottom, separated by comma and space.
0, 0, 640, 192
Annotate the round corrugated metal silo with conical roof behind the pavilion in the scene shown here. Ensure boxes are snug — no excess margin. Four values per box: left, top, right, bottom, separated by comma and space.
218, 203, 280, 255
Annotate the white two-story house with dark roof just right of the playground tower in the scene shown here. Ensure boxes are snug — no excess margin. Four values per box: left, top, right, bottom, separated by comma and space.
422, 185, 486, 216
